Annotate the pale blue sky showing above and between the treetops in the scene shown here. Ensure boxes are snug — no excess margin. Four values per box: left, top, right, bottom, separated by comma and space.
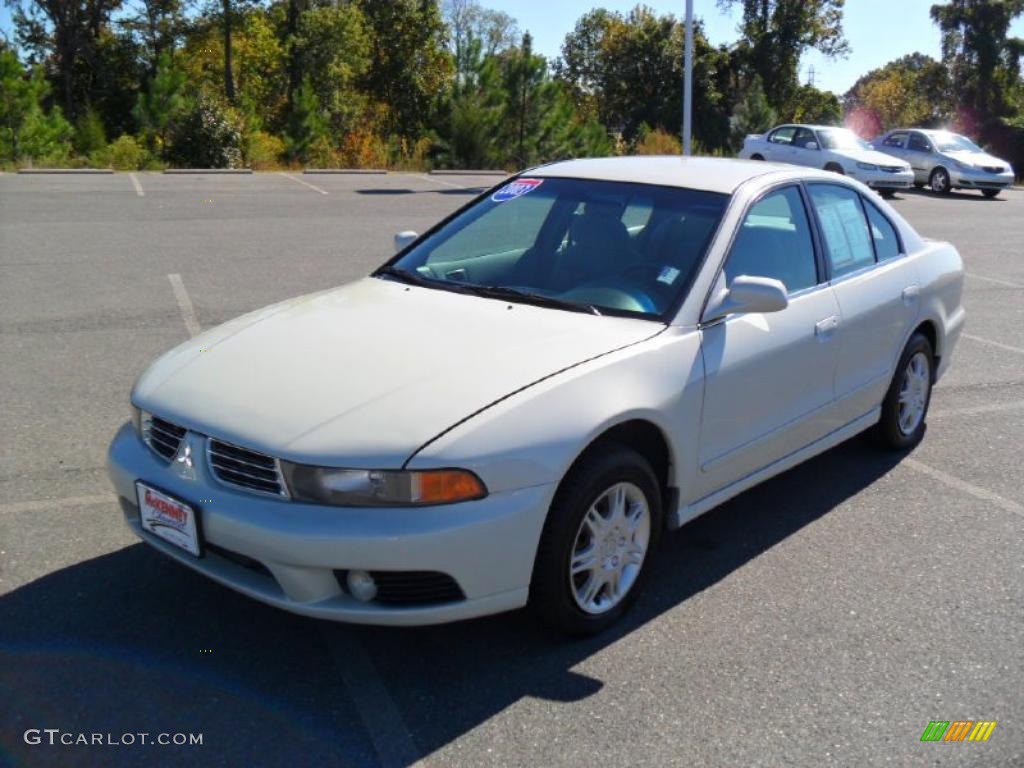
0, 0, 1024, 94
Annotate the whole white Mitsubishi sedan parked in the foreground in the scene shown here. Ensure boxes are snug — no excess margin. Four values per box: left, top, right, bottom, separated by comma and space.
110, 158, 964, 633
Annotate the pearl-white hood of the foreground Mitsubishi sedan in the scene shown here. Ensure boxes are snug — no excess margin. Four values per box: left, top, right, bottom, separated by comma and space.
132, 278, 665, 469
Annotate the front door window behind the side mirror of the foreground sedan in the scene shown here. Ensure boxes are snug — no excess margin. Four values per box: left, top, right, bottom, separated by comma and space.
725, 186, 818, 293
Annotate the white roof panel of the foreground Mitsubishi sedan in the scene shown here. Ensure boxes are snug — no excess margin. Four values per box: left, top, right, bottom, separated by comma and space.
524, 155, 794, 195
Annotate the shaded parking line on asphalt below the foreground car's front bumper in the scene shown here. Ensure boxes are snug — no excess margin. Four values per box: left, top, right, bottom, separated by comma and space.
322, 627, 426, 768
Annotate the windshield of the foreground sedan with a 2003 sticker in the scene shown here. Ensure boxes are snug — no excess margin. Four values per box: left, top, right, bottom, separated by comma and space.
376, 177, 729, 317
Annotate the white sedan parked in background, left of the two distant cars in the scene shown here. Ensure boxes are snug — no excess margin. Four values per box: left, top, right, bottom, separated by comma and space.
739, 125, 913, 198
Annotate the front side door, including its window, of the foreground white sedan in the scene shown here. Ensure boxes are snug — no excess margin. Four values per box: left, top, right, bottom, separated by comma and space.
696, 184, 839, 498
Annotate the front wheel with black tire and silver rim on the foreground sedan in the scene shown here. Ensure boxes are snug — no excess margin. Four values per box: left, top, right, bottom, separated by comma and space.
529, 443, 664, 635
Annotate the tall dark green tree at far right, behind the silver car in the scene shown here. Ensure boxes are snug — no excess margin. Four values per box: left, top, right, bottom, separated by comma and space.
932, 0, 1024, 126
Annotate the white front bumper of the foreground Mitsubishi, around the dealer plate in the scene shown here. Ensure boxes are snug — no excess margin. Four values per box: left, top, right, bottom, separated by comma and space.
108, 424, 554, 625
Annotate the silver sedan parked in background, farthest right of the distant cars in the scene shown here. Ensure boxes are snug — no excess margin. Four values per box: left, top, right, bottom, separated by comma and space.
872, 128, 1014, 198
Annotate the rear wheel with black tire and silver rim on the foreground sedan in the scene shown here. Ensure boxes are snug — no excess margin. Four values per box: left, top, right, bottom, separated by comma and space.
876, 334, 935, 451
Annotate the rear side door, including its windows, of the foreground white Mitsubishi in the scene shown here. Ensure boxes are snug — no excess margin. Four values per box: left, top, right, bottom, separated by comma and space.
807, 182, 920, 423
